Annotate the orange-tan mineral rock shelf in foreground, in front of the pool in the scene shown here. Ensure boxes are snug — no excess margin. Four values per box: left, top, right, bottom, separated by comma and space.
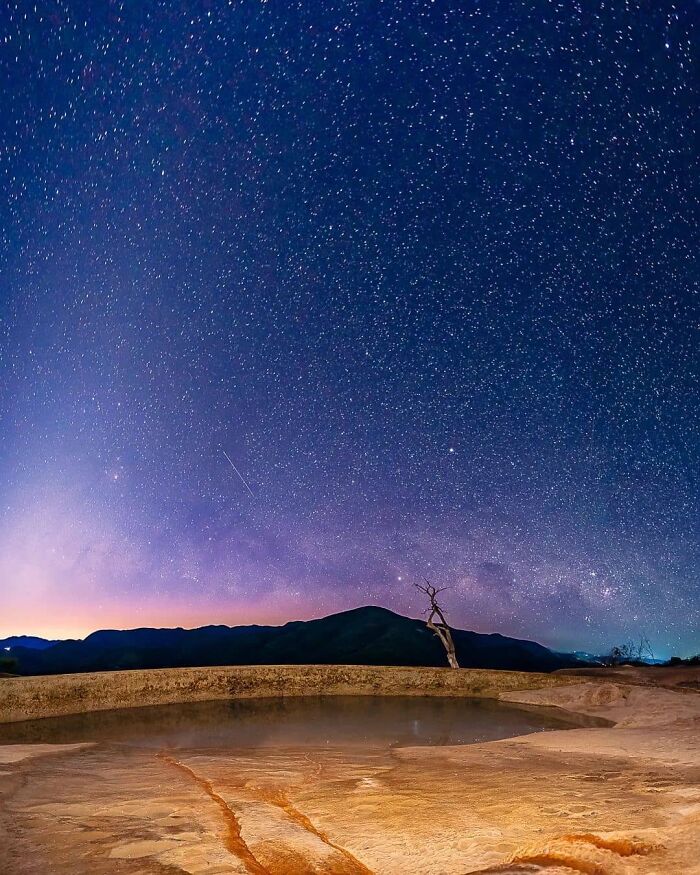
0, 669, 700, 875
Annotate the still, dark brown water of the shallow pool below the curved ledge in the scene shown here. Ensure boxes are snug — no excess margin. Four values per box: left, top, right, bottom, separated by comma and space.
0, 696, 591, 750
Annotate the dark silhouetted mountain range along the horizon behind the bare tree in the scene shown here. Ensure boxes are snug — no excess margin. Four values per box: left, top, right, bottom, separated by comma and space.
0, 606, 585, 675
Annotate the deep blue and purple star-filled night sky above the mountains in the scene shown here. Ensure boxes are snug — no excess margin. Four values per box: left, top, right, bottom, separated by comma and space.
0, 0, 700, 656
